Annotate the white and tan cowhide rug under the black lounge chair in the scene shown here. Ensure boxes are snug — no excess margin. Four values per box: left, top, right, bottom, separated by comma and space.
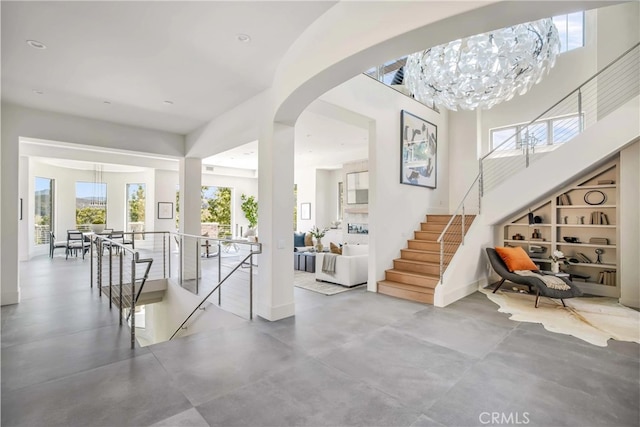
480, 289, 640, 347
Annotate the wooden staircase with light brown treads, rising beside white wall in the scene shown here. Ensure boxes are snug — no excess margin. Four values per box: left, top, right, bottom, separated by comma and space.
378, 215, 475, 304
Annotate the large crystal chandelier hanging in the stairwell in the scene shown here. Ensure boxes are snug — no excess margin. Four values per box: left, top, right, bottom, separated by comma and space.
404, 18, 560, 111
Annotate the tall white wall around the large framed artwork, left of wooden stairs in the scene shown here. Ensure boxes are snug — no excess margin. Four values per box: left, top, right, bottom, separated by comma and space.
321, 75, 449, 291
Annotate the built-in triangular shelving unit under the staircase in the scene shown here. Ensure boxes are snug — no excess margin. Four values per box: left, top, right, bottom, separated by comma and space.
502, 160, 620, 297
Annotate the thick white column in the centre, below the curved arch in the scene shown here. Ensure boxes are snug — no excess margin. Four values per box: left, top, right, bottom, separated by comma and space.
257, 123, 295, 320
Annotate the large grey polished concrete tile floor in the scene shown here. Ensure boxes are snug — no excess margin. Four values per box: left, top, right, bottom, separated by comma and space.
1, 257, 640, 427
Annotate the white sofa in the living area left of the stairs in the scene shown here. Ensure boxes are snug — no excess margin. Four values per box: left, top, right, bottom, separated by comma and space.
316, 245, 369, 287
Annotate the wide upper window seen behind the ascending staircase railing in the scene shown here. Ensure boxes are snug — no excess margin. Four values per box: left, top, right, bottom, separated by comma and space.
491, 114, 580, 151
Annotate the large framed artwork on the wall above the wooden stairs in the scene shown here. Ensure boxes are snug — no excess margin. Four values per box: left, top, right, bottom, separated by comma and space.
400, 110, 438, 188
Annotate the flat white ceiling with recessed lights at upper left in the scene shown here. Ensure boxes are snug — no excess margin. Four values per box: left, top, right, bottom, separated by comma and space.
1, 1, 335, 134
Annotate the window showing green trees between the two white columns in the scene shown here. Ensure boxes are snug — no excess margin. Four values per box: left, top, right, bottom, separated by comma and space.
200, 186, 232, 238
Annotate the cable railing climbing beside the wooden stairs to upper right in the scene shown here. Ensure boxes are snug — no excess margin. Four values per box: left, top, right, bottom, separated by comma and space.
437, 43, 640, 283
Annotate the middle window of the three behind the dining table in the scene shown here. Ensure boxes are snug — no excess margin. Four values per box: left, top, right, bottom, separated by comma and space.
76, 181, 107, 230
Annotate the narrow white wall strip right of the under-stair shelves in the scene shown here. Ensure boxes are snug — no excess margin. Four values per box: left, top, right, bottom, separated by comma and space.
618, 142, 640, 308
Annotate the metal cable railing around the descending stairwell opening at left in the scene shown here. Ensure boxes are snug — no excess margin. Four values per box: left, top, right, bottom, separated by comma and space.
86, 232, 262, 346
